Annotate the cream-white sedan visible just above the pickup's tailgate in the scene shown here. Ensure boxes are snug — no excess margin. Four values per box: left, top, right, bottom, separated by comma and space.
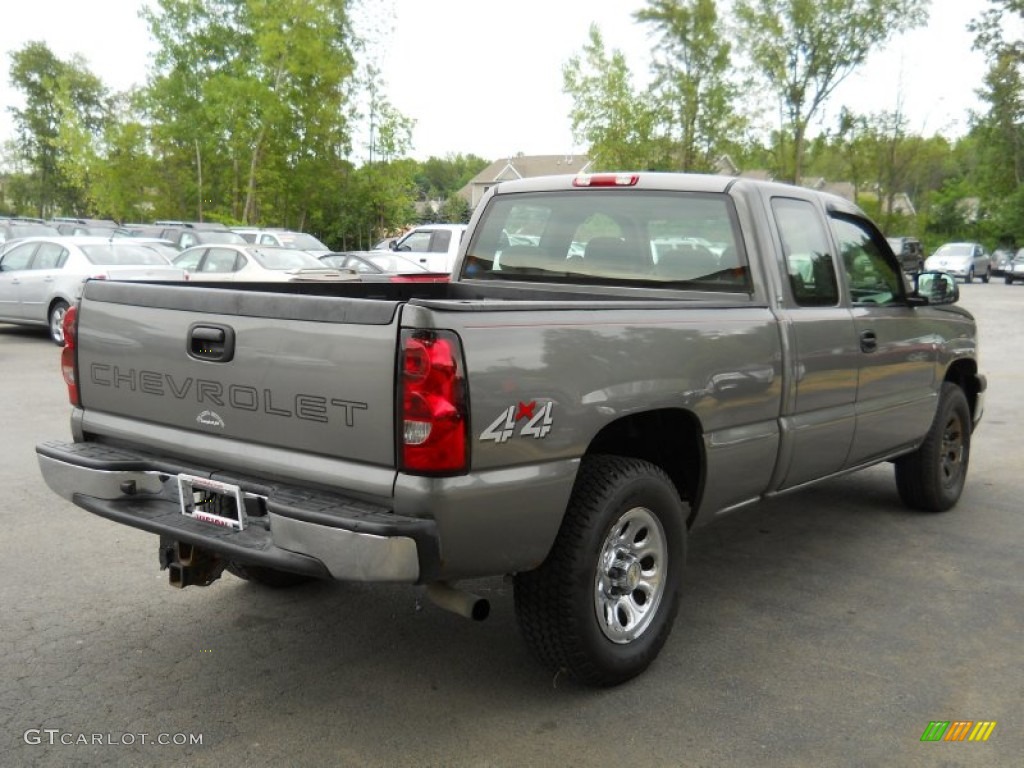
174, 244, 357, 283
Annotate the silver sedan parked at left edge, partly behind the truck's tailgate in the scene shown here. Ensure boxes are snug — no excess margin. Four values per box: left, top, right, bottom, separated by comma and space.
0, 237, 185, 344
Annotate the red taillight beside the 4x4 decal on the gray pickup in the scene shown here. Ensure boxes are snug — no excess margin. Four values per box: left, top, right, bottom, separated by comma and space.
398, 331, 469, 474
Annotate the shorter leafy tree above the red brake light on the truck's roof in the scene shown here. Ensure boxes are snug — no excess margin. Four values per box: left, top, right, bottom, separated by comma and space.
562, 25, 670, 170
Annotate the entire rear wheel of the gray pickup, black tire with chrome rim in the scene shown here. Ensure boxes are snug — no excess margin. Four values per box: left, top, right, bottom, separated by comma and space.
514, 456, 686, 686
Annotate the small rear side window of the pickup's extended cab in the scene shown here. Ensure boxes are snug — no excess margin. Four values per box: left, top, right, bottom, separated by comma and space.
771, 198, 839, 306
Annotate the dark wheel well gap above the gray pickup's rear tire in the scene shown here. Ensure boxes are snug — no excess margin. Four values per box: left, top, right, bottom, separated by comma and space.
587, 409, 705, 526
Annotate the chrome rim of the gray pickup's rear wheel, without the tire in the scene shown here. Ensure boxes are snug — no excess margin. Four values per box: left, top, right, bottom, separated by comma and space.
594, 507, 669, 643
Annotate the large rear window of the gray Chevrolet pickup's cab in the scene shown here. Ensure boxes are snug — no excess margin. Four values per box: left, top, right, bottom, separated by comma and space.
463, 189, 751, 292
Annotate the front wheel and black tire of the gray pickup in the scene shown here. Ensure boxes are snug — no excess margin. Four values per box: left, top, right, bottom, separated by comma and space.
896, 382, 971, 512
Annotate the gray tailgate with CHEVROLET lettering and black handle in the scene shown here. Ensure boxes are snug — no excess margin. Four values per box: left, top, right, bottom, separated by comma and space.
78, 282, 399, 466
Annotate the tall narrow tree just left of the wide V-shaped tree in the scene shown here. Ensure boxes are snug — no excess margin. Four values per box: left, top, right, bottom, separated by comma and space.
635, 0, 743, 171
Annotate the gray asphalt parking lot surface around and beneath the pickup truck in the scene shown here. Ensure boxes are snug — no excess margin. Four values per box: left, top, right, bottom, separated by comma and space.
0, 281, 1024, 768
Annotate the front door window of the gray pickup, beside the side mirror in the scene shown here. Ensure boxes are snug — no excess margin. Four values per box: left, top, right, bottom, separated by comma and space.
831, 215, 905, 304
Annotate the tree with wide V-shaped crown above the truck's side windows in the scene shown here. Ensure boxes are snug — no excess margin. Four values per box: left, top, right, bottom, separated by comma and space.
734, 0, 927, 181
